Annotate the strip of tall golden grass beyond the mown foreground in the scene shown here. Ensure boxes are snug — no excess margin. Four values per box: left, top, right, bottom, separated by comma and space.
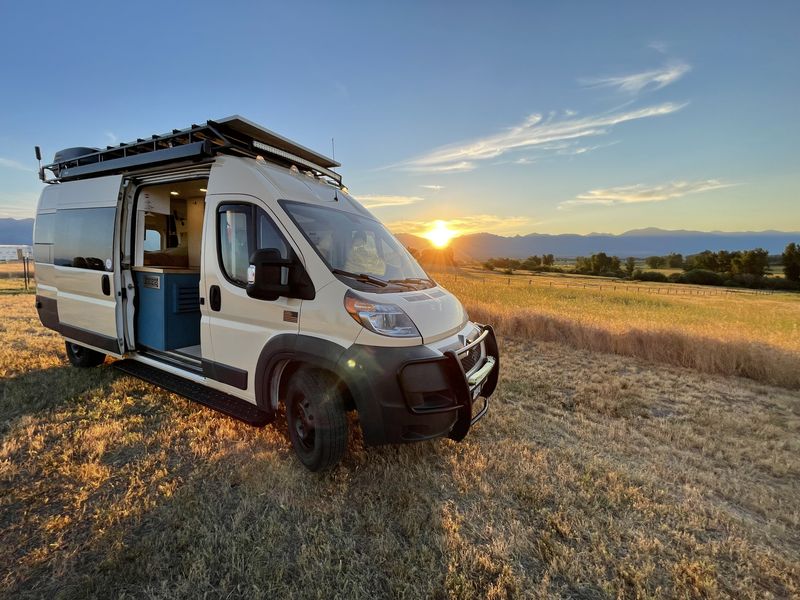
436, 272, 800, 388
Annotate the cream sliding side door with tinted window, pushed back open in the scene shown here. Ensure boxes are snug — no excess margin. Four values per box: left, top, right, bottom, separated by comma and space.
48, 175, 124, 355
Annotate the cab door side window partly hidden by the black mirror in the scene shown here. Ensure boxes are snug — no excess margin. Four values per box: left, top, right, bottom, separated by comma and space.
217, 204, 289, 287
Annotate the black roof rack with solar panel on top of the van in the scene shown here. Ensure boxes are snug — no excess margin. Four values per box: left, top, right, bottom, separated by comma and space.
39, 115, 342, 186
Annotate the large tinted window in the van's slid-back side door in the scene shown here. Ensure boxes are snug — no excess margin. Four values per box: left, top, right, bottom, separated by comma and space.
53, 208, 117, 271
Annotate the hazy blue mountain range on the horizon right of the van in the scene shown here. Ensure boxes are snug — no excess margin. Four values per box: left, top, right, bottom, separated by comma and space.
397, 227, 800, 260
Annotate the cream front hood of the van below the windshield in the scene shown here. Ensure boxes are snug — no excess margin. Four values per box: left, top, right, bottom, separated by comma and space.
364, 286, 468, 344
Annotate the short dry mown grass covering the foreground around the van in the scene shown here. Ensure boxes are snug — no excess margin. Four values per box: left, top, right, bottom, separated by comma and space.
0, 281, 800, 598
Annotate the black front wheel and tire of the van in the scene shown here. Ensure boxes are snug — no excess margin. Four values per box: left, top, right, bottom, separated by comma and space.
285, 369, 348, 471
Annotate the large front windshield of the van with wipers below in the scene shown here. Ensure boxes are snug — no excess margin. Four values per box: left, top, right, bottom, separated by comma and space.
281, 200, 435, 291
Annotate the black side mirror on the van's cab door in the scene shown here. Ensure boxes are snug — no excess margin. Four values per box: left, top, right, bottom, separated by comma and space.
247, 248, 315, 301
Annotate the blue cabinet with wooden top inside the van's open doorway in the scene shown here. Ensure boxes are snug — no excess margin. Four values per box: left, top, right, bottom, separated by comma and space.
134, 267, 200, 350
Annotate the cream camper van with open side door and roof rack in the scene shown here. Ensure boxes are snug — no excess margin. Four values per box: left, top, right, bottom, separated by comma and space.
34, 117, 499, 470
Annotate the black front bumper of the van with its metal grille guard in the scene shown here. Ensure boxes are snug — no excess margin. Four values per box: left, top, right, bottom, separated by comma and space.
339, 325, 500, 445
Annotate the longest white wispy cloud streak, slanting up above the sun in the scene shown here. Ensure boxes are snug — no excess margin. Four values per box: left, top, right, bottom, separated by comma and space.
394, 102, 685, 173
